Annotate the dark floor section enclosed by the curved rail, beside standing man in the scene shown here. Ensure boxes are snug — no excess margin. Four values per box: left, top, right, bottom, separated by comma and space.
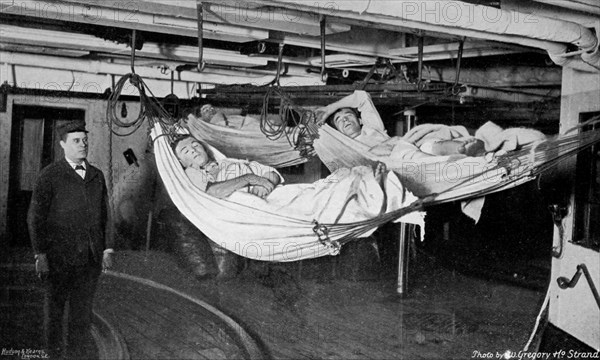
95, 276, 244, 359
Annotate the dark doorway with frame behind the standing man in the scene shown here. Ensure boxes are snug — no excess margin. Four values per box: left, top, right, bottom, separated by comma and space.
7, 106, 85, 247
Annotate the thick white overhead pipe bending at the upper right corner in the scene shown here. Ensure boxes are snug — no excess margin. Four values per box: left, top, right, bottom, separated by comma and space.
246, 0, 600, 71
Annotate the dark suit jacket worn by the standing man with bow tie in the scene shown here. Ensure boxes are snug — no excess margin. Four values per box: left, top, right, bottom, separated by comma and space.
27, 158, 113, 271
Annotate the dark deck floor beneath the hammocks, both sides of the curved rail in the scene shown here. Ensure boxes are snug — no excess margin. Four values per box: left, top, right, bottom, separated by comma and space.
96, 252, 544, 359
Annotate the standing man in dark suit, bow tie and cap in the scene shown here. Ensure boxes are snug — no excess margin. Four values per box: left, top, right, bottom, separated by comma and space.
27, 121, 113, 359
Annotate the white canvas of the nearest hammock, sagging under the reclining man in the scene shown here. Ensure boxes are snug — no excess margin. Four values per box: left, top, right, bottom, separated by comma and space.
152, 127, 422, 261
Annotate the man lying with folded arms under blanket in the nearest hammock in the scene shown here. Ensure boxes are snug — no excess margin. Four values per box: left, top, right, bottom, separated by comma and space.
172, 136, 408, 223
